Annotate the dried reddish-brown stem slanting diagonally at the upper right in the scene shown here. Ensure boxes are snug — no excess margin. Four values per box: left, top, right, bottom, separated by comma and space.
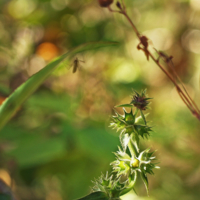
108, 0, 200, 120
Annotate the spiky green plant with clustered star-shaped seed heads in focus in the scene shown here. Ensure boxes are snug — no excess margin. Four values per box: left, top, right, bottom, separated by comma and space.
79, 90, 159, 200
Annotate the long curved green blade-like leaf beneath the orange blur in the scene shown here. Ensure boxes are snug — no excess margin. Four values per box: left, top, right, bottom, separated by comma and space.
0, 42, 117, 129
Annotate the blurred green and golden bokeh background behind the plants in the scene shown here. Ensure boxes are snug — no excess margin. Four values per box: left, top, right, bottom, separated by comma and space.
0, 0, 200, 200
